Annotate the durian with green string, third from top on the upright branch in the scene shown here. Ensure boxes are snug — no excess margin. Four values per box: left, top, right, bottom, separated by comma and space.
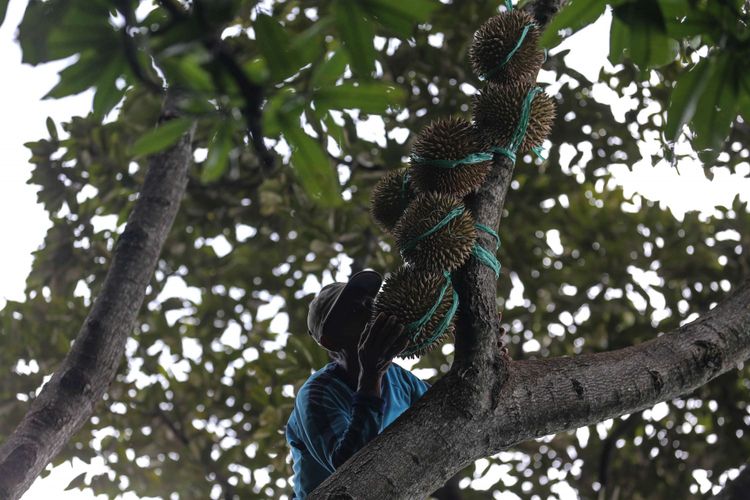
412, 117, 492, 198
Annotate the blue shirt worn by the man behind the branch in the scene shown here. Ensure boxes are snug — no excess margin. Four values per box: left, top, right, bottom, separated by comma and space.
286, 361, 430, 499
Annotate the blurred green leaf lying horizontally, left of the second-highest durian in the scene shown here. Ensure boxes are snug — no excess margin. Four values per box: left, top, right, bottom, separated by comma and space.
313, 82, 406, 113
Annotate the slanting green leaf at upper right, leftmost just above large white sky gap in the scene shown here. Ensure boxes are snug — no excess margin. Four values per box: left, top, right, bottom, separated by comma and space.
664, 59, 712, 142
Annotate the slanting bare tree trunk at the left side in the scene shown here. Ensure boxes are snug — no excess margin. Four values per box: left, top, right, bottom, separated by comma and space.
0, 98, 193, 500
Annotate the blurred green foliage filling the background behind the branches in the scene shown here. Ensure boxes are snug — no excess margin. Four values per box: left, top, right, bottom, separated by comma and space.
0, 0, 750, 499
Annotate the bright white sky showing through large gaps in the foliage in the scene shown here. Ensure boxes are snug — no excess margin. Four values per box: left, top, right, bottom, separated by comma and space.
0, 0, 750, 500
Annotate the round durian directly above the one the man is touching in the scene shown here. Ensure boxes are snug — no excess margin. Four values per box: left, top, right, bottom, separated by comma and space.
393, 192, 477, 272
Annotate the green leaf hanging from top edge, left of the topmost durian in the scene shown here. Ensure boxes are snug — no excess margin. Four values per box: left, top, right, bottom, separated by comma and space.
332, 0, 375, 78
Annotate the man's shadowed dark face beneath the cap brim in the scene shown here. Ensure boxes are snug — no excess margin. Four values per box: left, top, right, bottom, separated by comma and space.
318, 291, 373, 351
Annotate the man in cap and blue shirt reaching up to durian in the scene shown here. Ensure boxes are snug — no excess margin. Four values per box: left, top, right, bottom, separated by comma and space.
286, 270, 420, 498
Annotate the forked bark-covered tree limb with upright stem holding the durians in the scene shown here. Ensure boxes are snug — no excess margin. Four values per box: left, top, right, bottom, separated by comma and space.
310, 0, 750, 500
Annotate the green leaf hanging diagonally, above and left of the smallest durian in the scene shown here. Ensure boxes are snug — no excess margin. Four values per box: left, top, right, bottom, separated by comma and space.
283, 125, 341, 207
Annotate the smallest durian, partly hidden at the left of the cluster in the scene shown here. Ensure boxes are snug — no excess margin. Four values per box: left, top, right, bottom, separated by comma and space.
370, 168, 415, 233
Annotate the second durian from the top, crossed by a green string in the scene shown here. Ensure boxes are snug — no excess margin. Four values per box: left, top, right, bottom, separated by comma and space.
472, 83, 555, 153
